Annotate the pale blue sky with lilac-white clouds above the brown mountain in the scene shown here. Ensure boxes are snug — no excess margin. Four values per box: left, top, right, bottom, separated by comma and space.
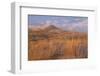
28, 15, 88, 32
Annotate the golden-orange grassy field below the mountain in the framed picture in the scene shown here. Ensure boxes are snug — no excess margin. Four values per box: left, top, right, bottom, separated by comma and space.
28, 25, 88, 60
